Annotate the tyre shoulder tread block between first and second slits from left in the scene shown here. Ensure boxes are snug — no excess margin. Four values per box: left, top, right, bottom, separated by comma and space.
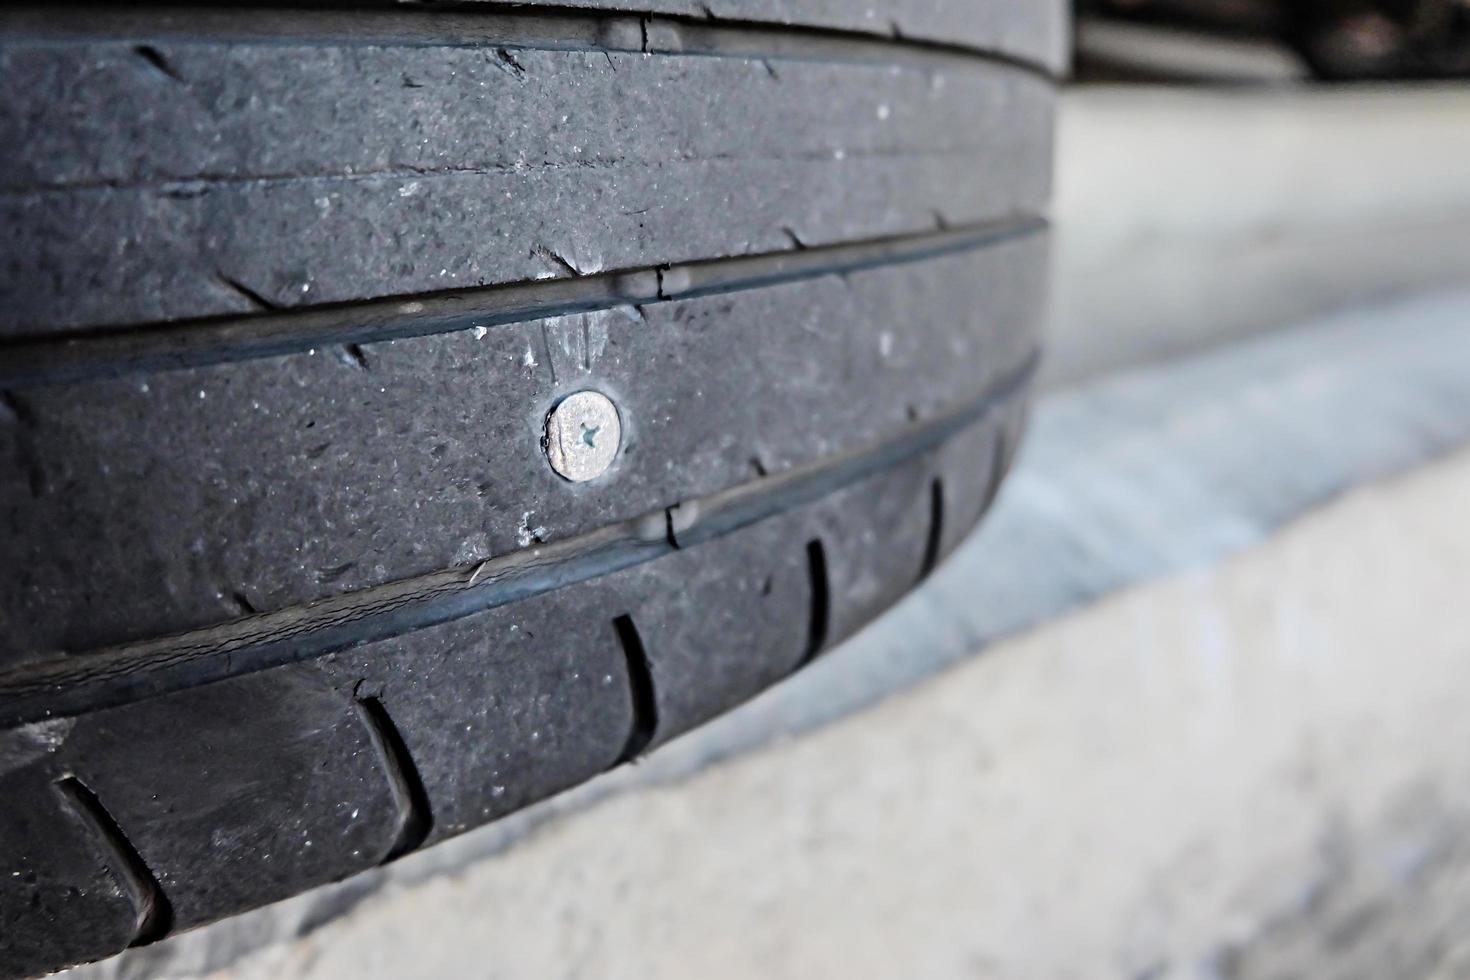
56, 669, 403, 929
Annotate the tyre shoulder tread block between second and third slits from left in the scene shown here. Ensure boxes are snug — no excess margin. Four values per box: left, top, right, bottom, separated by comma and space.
312, 588, 634, 843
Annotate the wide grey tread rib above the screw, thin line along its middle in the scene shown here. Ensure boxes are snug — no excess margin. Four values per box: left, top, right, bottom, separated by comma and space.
0, 3, 1051, 335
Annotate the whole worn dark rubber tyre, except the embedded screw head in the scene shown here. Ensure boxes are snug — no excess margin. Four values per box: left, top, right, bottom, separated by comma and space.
0, 0, 1060, 976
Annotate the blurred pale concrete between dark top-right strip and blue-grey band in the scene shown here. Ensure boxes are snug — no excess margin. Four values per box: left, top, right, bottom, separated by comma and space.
1044, 85, 1470, 386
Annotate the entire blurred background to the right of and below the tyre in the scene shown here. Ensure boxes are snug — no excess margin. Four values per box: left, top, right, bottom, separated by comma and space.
78, 0, 1470, 980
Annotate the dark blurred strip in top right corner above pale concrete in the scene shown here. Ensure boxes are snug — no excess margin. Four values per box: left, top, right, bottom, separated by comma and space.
1078, 0, 1470, 81
